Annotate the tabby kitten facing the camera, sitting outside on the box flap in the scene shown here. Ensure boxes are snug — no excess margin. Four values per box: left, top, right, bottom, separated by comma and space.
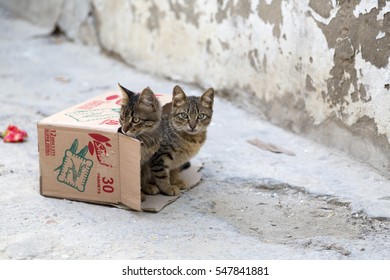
150, 86, 214, 195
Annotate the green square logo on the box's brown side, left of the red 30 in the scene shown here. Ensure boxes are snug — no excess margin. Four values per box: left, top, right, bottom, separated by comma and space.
54, 139, 93, 192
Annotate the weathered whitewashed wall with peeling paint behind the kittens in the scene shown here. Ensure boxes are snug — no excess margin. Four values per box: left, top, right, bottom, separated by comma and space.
0, 0, 390, 174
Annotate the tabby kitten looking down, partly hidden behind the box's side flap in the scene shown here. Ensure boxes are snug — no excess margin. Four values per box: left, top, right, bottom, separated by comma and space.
118, 83, 161, 194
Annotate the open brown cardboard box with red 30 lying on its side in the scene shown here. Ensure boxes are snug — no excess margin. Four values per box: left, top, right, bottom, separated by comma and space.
37, 92, 201, 212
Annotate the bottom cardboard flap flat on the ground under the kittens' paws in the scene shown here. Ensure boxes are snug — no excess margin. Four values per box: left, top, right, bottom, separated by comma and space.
141, 160, 203, 212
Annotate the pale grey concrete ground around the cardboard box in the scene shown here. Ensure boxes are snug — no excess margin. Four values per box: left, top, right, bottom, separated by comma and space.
0, 15, 390, 259
